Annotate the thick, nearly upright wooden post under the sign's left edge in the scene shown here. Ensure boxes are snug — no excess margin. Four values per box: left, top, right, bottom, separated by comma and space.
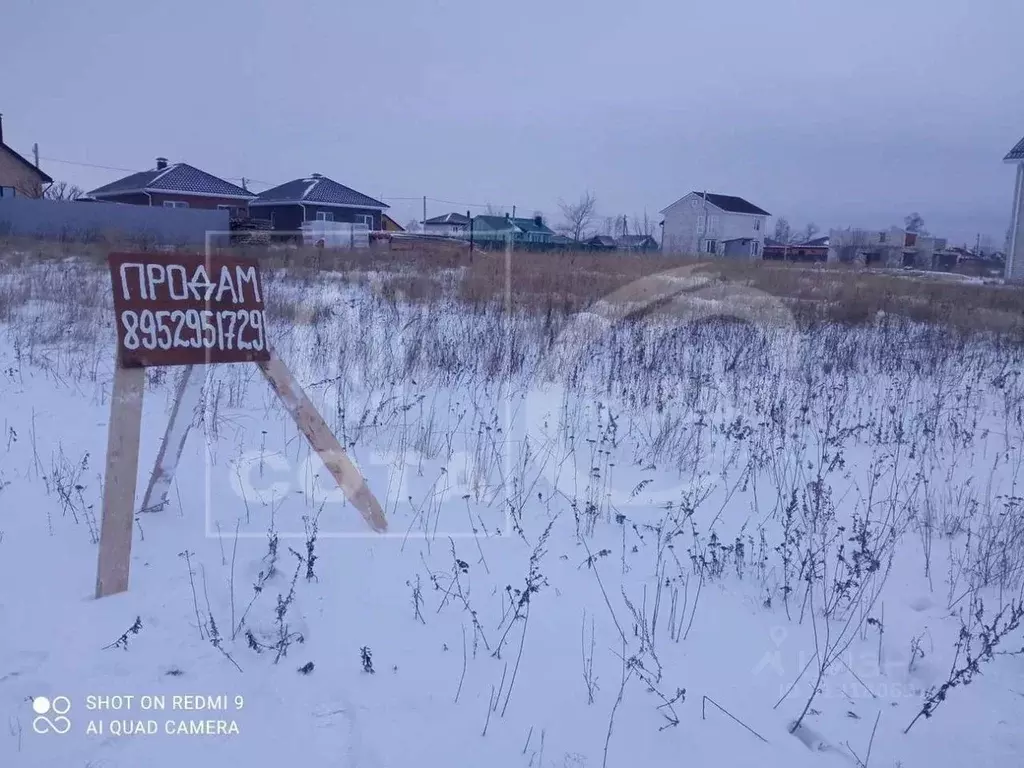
96, 360, 145, 598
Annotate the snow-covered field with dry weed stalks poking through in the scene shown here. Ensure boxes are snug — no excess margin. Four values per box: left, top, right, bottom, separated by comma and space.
0, 249, 1024, 768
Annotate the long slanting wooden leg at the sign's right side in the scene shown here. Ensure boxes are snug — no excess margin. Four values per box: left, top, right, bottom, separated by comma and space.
256, 349, 387, 532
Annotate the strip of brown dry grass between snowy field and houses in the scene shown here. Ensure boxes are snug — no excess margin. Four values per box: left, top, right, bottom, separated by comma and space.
6, 240, 1024, 338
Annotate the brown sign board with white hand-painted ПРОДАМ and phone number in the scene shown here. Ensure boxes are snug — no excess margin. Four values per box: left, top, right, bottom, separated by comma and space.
108, 253, 270, 368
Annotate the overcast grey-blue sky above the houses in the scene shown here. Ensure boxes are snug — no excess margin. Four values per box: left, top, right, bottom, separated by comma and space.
0, 0, 1024, 245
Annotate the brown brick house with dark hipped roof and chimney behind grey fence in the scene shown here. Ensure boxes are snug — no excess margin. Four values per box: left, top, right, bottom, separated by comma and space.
88, 158, 256, 218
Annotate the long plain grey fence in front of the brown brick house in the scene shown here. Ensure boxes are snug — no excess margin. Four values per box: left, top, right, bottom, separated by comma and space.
0, 198, 229, 246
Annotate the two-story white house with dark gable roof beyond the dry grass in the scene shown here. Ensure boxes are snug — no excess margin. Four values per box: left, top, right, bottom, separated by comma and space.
662, 191, 771, 259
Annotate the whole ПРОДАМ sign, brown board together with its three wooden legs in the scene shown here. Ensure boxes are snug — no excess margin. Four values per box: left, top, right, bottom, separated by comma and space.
96, 253, 387, 598
